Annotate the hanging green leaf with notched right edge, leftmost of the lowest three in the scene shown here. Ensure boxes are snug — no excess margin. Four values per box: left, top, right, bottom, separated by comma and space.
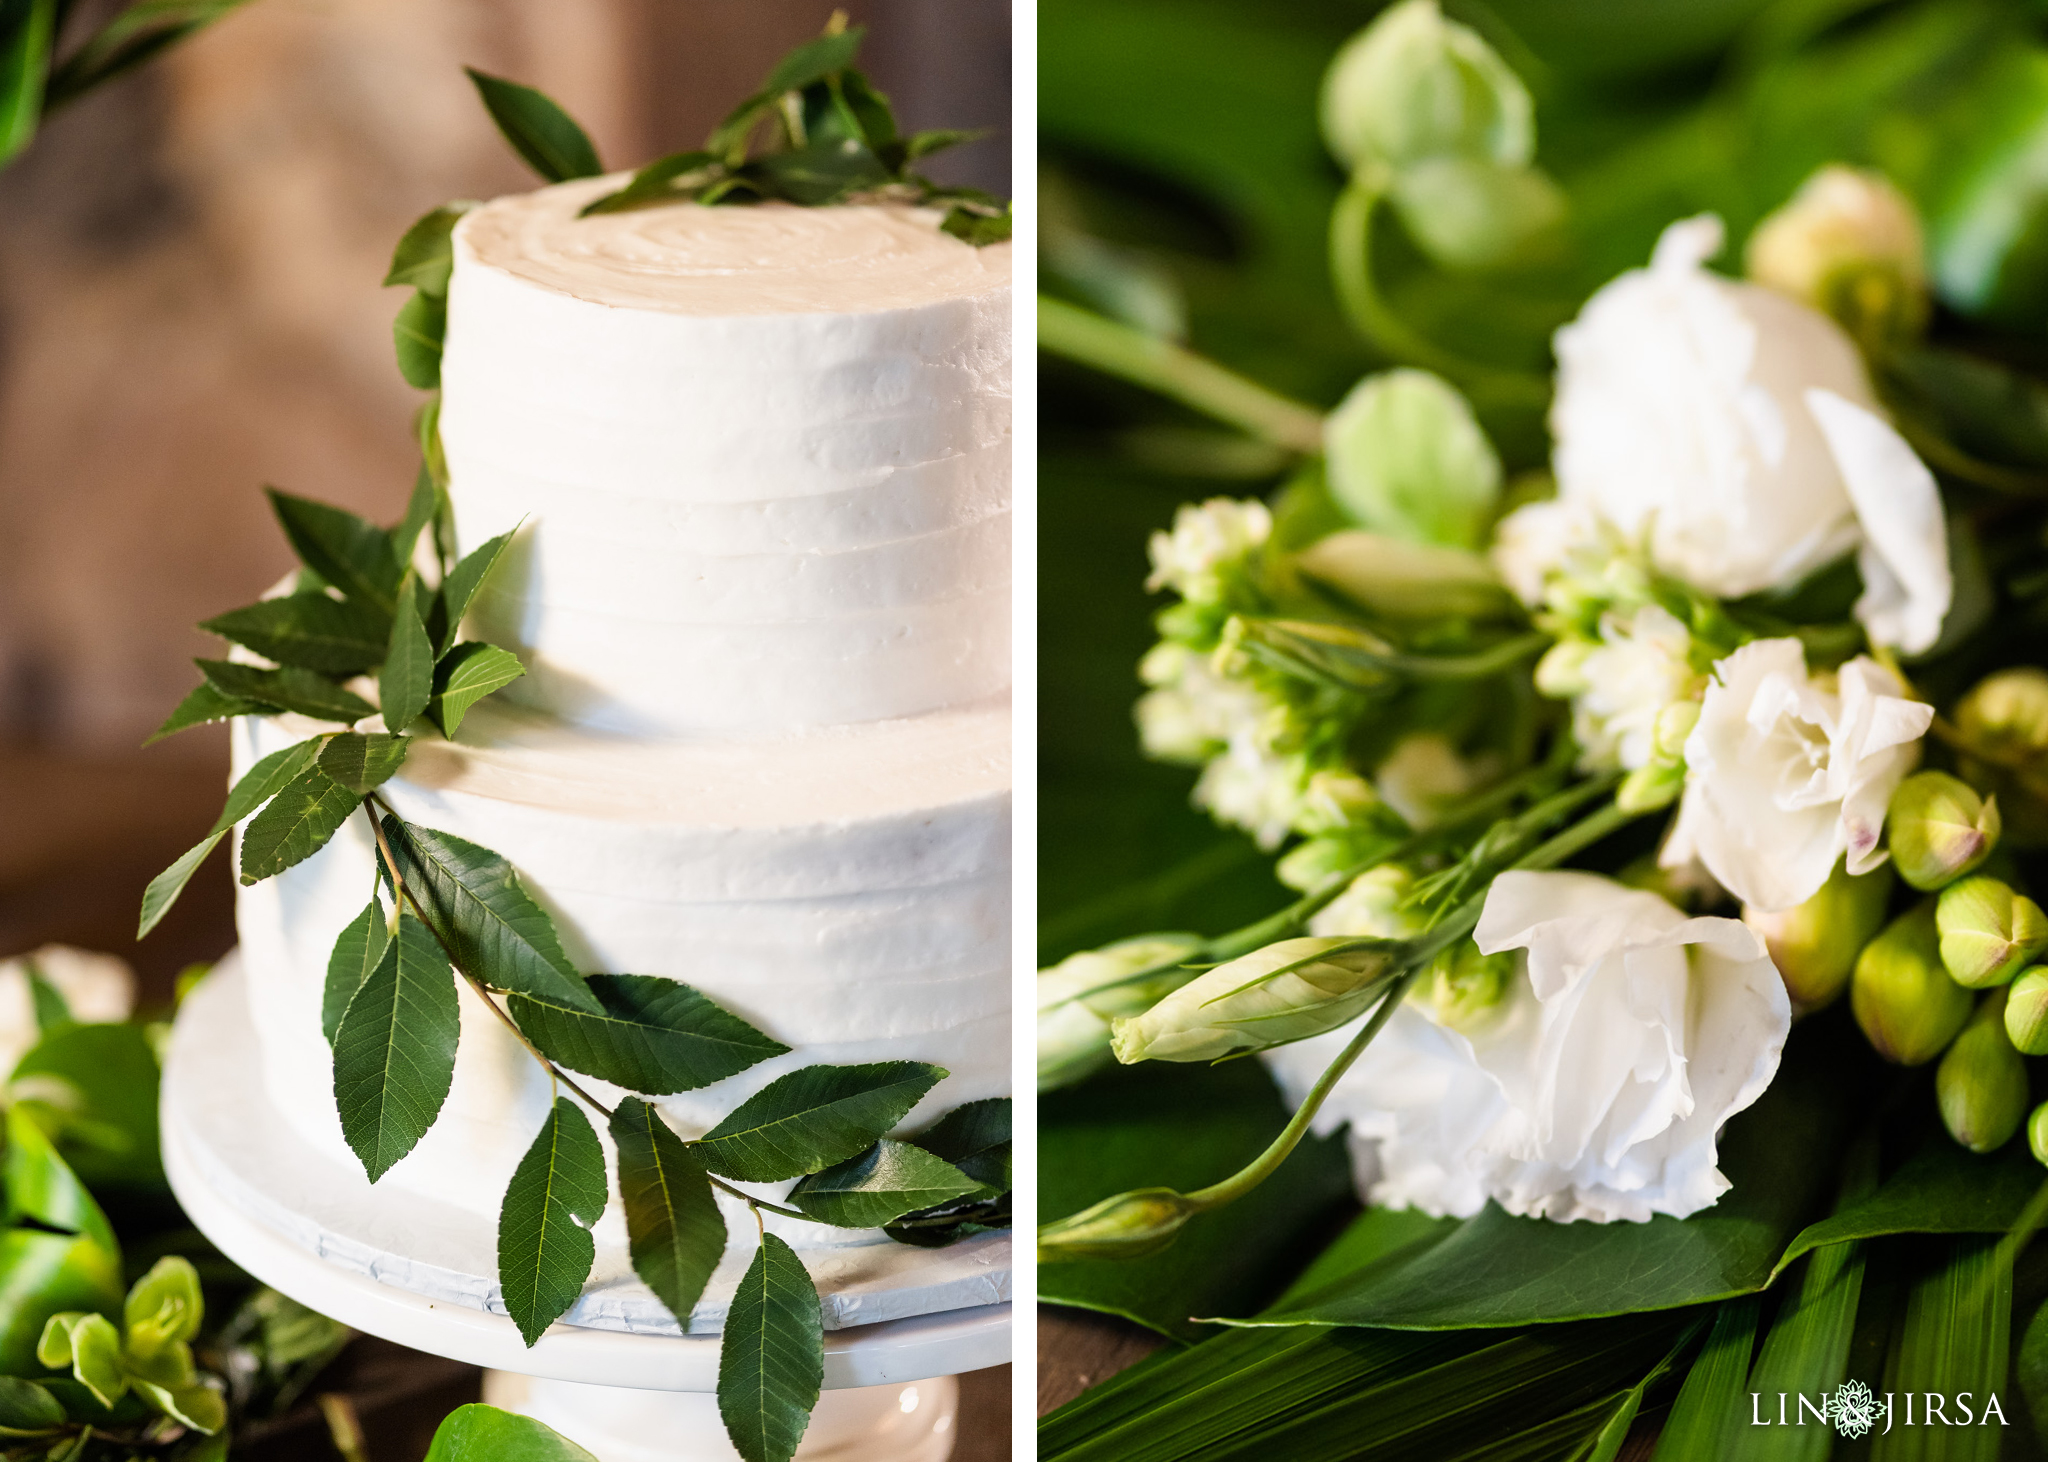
498, 1098, 606, 1345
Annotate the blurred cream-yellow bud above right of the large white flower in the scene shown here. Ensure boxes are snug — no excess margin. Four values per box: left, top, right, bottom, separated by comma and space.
1745, 164, 1927, 340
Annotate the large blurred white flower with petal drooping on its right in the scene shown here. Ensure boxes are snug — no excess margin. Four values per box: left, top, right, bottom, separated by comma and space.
1550, 215, 1954, 653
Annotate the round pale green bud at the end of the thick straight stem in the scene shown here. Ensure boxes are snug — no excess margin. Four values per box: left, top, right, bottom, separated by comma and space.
1323, 371, 1501, 549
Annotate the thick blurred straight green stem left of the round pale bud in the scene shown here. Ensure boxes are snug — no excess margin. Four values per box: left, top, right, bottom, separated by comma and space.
1038, 295, 1323, 455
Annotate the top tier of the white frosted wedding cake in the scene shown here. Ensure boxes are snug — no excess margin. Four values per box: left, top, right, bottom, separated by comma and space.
440, 178, 1010, 737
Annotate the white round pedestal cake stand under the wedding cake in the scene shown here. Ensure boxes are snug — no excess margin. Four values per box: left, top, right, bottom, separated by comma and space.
162, 960, 1010, 1462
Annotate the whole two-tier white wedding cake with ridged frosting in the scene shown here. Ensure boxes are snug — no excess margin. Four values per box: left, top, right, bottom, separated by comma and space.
222, 178, 1012, 1321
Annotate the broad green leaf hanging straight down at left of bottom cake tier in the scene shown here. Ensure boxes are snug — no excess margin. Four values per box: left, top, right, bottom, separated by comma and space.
334, 909, 463, 1184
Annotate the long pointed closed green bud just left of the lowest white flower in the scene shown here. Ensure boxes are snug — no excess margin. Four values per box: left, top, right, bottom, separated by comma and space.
1110, 938, 1401, 1065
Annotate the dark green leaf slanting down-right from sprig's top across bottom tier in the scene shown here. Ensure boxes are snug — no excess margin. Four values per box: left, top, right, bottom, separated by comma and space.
383, 815, 604, 1016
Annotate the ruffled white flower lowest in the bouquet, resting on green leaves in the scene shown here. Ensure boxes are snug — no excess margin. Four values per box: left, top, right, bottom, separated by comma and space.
1266, 872, 1792, 1222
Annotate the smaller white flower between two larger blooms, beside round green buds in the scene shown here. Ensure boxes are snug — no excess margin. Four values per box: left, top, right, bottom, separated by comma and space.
1661, 639, 1933, 913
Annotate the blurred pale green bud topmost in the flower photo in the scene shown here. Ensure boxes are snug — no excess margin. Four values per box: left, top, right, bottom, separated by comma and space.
1319, 0, 1536, 170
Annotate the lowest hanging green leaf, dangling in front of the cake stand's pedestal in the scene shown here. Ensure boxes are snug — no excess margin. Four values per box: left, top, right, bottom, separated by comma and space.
719, 1233, 825, 1462
